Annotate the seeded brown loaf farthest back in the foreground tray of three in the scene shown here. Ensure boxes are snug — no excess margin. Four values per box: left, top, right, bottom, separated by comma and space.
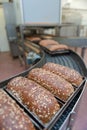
43, 62, 83, 86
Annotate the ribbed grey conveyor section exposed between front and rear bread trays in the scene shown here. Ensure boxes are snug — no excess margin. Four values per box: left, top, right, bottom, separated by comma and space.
45, 50, 87, 77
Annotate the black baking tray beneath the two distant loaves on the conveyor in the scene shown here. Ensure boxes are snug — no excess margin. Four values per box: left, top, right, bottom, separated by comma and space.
40, 45, 70, 55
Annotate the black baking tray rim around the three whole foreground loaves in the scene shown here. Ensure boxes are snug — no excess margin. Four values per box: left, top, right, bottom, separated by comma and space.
4, 76, 85, 130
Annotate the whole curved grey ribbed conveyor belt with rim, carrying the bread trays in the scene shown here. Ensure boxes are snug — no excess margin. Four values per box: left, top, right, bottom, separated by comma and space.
0, 51, 87, 130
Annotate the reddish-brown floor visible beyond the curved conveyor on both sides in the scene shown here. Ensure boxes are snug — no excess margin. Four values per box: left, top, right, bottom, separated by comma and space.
0, 48, 87, 82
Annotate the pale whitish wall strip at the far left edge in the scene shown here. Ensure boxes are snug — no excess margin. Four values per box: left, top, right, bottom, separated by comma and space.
0, 6, 10, 52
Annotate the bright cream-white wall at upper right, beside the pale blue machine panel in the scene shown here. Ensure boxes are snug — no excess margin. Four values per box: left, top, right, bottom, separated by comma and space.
62, 0, 87, 37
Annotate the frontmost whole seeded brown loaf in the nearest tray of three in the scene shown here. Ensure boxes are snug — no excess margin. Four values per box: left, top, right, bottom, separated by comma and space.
7, 77, 60, 123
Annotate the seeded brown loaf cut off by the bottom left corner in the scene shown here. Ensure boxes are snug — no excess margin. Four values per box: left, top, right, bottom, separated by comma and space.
0, 90, 35, 130
